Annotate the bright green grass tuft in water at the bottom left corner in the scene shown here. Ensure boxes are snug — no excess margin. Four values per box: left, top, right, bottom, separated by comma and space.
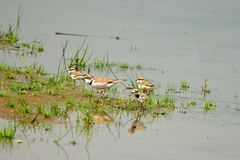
0, 125, 16, 141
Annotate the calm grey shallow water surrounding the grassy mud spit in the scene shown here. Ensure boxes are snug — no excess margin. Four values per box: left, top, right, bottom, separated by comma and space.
0, 0, 240, 160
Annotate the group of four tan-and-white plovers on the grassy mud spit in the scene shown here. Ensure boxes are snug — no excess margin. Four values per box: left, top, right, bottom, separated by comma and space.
66, 67, 154, 103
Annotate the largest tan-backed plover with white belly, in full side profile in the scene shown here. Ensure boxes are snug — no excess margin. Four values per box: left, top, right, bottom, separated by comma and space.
84, 74, 126, 96
